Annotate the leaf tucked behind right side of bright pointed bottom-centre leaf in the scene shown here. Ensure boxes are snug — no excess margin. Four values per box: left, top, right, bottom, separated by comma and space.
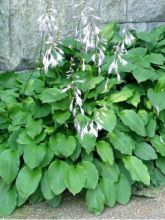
82, 161, 99, 189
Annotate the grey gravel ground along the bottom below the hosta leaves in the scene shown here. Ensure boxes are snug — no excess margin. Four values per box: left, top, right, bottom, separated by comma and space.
9, 189, 165, 219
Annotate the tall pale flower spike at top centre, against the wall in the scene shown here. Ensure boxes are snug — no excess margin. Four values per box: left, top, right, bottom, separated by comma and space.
75, 0, 107, 73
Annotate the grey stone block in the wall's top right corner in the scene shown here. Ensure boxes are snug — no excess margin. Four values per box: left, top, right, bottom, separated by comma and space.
127, 0, 165, 22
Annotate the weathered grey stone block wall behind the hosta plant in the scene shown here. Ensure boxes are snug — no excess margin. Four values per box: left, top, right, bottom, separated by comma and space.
0, 0, 165, 70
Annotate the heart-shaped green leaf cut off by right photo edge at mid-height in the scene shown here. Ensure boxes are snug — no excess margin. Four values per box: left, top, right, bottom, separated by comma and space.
147, 89, 165, 112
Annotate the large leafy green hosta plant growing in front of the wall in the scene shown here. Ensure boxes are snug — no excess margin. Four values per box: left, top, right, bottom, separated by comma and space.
0, 24, 165, 216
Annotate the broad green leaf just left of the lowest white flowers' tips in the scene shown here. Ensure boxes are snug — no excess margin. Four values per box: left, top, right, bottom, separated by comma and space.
49, 133, 76, 157
